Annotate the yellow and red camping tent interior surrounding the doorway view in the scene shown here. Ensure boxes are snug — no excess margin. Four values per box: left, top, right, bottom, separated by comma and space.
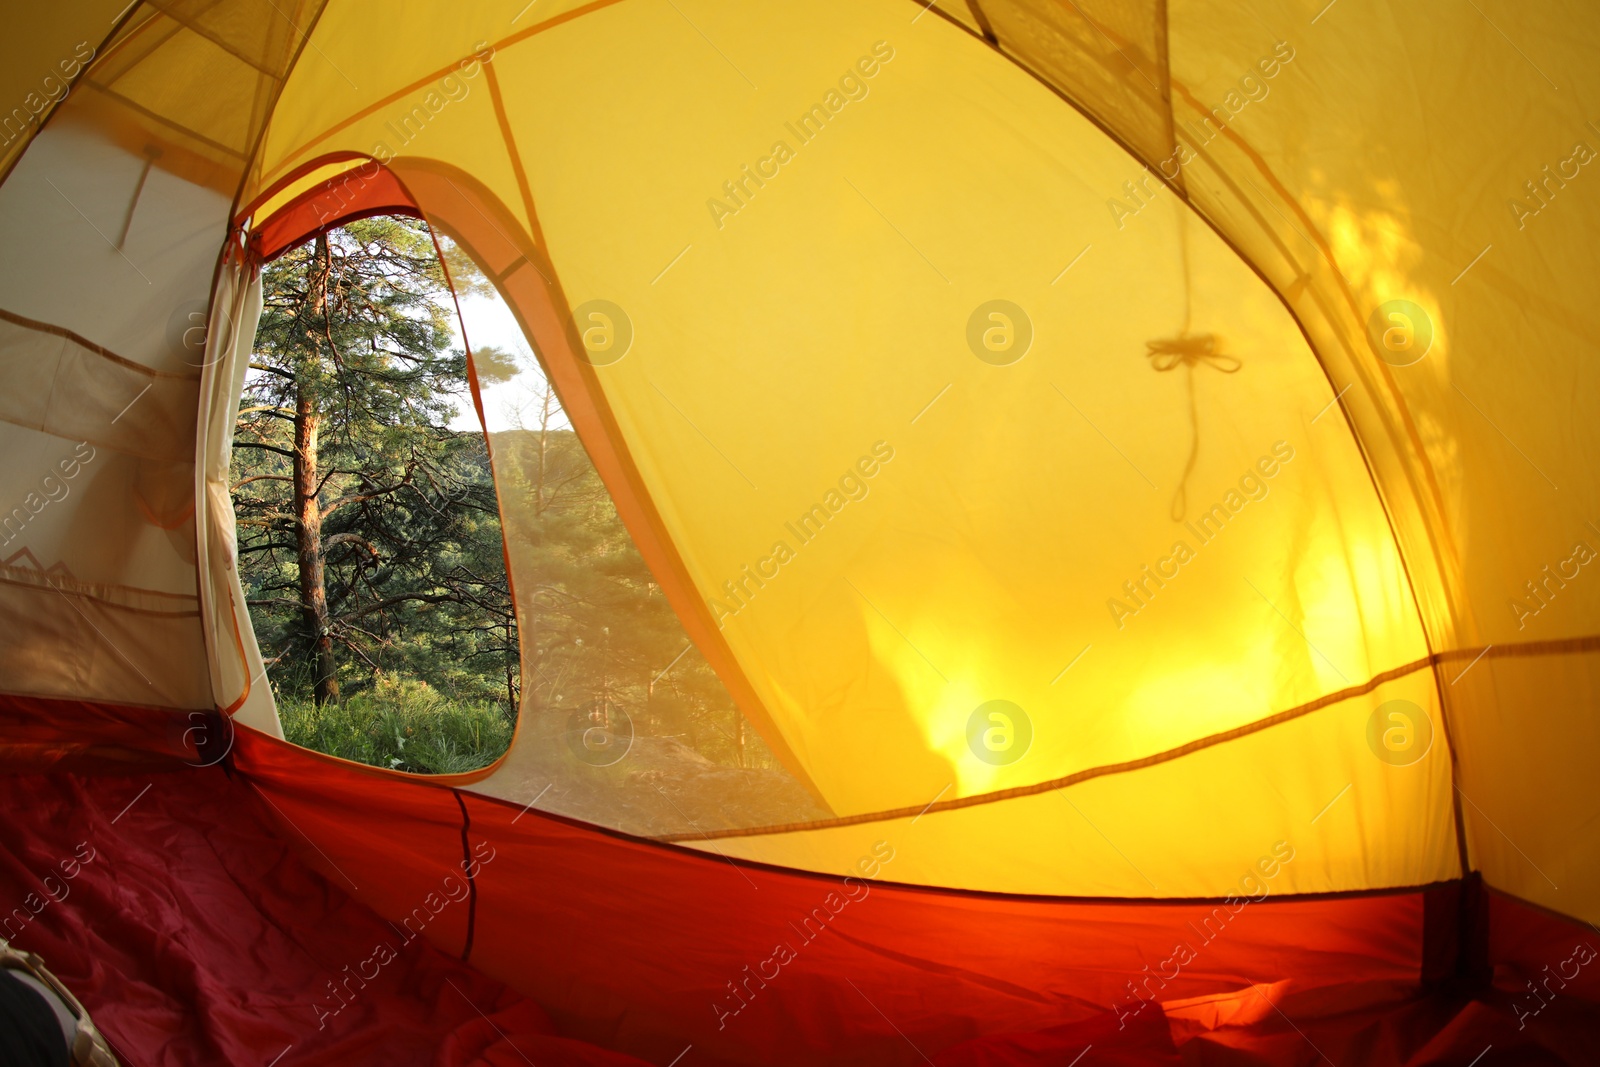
0, 0, 1600, 1067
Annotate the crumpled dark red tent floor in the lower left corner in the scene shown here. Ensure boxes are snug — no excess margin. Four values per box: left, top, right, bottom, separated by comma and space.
0, 769, 640, 1067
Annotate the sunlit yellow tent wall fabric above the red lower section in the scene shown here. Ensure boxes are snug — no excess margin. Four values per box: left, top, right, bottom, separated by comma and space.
0, 0, 1600, 921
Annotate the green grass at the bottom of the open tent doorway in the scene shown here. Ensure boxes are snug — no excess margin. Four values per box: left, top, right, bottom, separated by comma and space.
278, 677, 512, 774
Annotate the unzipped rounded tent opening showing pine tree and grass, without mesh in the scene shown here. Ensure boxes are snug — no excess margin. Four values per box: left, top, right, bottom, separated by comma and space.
232, 216, 522, 773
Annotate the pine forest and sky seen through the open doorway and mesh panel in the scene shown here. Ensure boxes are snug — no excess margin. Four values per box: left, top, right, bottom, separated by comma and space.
232, 218, 810, 829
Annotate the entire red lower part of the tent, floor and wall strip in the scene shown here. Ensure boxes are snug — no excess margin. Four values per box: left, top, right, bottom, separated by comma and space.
0, 731, 1600, 1067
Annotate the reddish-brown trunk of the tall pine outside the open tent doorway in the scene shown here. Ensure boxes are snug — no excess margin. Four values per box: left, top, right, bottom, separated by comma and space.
294, 237, 339, 707
